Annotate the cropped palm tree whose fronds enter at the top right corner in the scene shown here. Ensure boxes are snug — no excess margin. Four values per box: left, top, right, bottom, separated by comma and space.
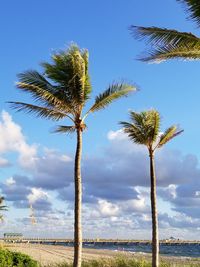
130, 0, 200, 62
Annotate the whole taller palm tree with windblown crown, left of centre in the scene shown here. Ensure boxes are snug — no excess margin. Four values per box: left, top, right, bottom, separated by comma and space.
10, 45, 136, 267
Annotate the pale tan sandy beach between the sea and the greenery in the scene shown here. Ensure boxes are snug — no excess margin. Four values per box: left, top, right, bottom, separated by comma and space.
7, 244, 200, 266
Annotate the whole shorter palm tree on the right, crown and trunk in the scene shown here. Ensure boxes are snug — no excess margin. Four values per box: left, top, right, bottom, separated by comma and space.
120, 110, 182, 267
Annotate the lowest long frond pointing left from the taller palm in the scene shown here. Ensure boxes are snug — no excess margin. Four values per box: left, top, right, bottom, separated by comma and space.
8, 102, 67, 121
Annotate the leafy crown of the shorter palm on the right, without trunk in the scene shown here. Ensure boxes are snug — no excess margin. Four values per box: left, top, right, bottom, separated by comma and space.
120, 110, 183, 152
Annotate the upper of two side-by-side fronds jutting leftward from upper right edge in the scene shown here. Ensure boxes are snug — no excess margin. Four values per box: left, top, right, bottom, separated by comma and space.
130, 26, 200, 46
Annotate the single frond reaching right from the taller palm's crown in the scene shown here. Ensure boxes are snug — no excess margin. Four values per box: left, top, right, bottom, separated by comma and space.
87, 83, 136, 113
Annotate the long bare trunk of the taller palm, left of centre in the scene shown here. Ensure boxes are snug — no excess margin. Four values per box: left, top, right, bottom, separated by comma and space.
73, 129, 82, 267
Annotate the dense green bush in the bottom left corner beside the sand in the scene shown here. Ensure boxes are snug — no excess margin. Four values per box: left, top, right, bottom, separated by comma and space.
0, 249, 38, 267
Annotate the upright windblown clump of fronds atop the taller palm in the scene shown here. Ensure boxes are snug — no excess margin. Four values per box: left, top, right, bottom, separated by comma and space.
42, 45, 91, 107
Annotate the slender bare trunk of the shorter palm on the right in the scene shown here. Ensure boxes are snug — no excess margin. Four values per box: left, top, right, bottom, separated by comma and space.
149, 151, 159, 267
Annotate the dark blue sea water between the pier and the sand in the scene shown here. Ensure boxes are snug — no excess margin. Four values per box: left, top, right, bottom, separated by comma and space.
44, 242, 200, 258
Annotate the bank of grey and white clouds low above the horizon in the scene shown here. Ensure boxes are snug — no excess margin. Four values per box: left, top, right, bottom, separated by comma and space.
0, 111, 200, 239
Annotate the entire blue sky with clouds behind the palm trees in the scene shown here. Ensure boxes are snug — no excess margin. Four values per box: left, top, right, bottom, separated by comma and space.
0, 0, 200, 239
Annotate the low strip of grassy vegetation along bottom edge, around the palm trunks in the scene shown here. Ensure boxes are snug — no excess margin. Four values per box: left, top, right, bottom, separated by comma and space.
45, 258, 198, 267
